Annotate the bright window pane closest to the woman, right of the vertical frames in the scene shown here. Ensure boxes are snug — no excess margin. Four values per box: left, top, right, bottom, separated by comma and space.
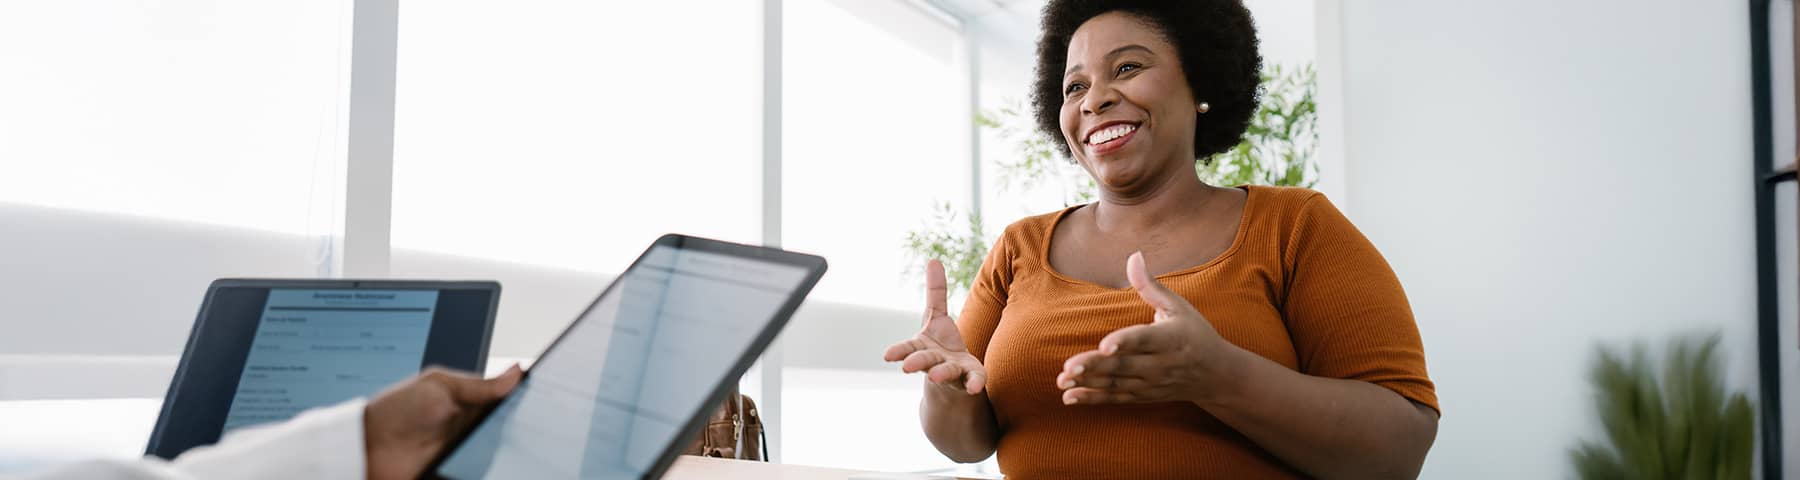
781, 0, 972, 471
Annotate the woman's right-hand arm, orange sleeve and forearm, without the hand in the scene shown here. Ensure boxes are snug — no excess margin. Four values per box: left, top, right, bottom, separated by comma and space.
1201, 194, 1438, 478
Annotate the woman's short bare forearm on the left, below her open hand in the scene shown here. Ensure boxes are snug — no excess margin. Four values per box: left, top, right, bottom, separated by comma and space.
918, 381, 999, 464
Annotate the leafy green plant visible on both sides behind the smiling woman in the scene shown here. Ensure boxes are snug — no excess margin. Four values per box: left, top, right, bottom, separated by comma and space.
905, 63, 1319, 297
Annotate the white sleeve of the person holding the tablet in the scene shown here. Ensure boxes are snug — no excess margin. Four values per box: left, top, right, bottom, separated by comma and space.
3, 399, 367, 480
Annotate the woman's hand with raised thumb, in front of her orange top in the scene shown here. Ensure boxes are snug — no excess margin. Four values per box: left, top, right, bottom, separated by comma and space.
1057, 252, 1247, 404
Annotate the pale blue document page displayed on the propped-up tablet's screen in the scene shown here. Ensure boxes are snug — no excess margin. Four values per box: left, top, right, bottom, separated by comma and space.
225, 289, 437, 431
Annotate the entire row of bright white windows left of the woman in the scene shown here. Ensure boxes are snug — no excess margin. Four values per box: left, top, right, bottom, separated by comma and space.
0, 0, 1008, 471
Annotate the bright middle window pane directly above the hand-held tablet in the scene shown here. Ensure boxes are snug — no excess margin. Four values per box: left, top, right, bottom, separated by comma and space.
392, 0, 761, 275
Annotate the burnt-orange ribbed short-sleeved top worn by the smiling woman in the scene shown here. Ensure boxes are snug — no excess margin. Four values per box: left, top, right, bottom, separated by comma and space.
958, 187, 1438, 480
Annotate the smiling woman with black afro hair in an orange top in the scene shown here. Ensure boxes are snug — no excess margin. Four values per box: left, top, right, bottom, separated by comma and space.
886, 0, 1438, 478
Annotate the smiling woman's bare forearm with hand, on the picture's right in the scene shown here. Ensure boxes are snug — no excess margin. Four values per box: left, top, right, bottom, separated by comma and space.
1057, 255, 1438, 478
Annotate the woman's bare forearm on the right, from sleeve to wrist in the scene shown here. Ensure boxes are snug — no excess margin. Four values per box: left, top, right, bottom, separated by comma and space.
1195, 349, 1438, 478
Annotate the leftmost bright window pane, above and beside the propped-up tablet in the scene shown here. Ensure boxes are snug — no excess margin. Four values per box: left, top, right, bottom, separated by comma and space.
0, 0, 349, 361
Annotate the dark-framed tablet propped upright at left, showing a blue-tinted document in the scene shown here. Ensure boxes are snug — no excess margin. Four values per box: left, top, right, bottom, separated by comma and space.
144, 279, 500, 458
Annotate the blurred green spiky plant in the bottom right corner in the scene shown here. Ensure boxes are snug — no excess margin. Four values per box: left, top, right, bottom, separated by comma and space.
1570, 334, 1755, 480
